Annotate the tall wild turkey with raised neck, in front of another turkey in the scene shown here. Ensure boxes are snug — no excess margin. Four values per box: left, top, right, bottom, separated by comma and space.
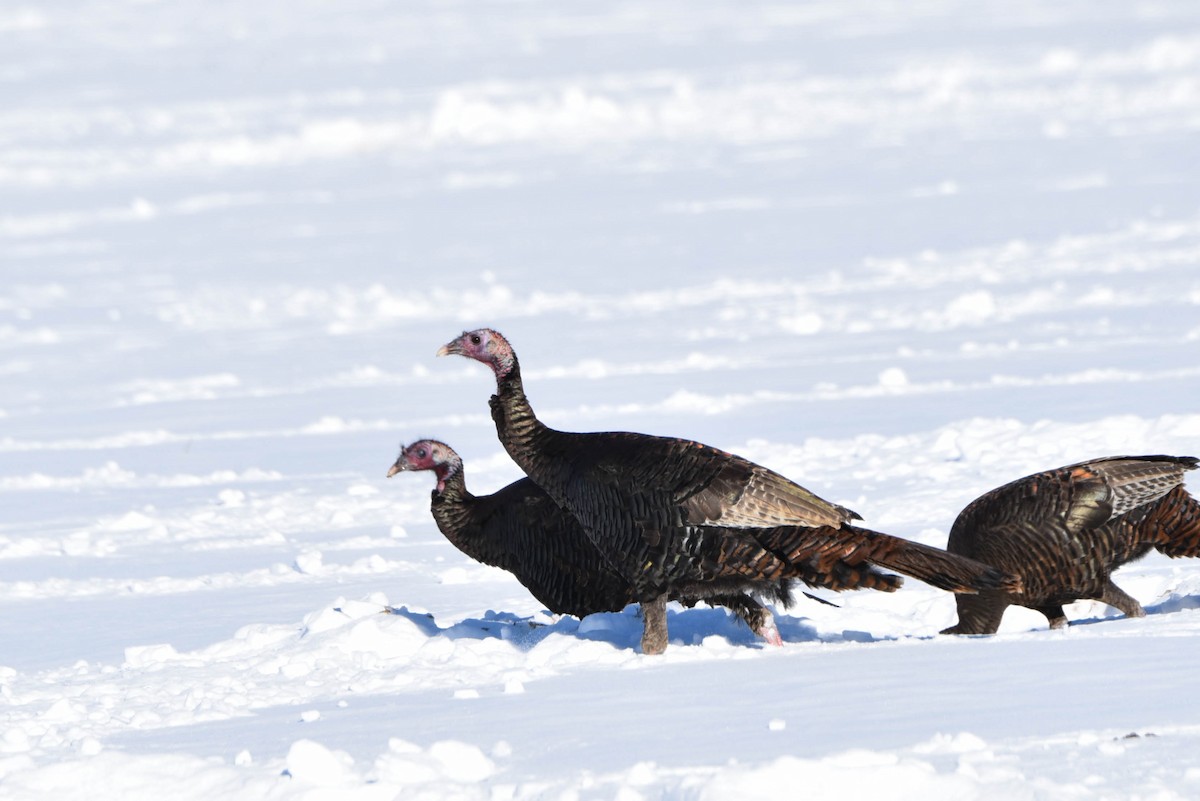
438, 329, 1018, 654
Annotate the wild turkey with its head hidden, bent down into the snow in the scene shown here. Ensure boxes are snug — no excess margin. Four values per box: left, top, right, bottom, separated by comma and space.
942, 456, 1200, 634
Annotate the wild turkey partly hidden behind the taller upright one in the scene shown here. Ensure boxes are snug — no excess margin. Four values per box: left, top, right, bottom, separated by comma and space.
388, 440, 791, 645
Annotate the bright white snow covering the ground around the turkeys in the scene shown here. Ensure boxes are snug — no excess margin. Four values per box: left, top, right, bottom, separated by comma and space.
0, 0, 1200, 801
